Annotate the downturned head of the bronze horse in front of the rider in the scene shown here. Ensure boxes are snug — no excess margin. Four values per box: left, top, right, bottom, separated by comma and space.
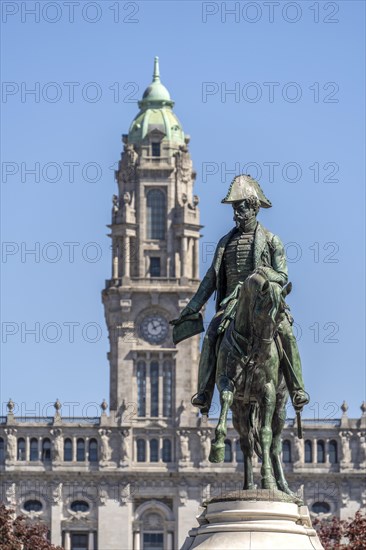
242, 272, 291, 360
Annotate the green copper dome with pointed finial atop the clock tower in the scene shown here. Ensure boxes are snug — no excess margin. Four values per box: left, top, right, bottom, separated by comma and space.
128, 57, 184, 145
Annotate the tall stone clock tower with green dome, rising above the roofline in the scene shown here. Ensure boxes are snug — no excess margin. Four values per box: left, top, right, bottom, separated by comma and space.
103, 57, 201, 432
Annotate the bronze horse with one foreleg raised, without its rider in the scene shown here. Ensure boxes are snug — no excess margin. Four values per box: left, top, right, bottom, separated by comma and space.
209, 269, 293, 495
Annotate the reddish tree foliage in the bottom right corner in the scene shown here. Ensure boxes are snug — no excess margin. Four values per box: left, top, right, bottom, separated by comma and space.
313, 511, 366, 550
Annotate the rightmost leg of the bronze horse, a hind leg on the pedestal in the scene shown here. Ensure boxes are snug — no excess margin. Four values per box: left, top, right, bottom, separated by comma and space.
271, 391, 295, 496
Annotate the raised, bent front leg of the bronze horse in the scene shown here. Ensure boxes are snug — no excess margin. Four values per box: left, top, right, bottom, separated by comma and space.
208, 376, 234, 462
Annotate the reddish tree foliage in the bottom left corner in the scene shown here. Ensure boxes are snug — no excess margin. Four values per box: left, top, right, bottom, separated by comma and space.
0, 503, 62, 550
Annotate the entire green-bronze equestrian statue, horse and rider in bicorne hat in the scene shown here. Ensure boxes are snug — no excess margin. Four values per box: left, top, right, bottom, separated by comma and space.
173, 175, 309, 494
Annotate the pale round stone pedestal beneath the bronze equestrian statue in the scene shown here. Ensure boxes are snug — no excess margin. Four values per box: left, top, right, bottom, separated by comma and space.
181, 489, 323, 550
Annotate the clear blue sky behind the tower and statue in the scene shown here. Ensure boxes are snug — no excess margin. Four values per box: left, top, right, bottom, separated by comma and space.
1, 1, 365, 417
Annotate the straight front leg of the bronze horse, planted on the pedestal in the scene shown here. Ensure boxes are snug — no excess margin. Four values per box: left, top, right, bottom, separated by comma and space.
259, 382, 277, 489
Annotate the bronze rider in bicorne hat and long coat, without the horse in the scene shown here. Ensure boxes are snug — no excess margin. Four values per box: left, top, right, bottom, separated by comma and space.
177, 175, 309, 414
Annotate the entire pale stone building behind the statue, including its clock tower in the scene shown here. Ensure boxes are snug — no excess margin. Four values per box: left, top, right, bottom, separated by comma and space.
0, 62, 366, 550
